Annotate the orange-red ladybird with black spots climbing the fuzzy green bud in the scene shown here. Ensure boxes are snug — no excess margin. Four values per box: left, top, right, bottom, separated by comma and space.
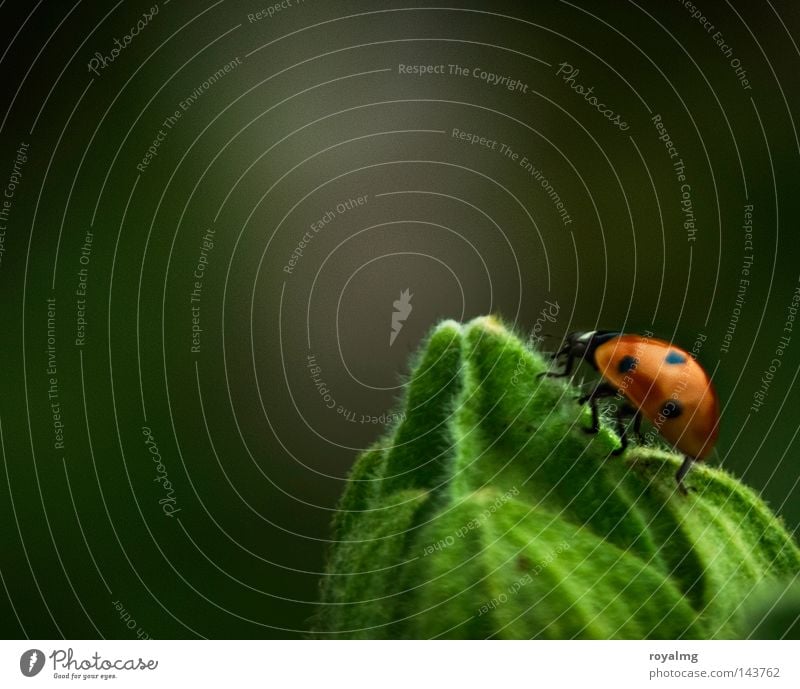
547, 330, 719, 491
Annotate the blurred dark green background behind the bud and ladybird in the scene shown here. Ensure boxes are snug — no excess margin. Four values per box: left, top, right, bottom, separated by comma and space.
0, 0, 800, 638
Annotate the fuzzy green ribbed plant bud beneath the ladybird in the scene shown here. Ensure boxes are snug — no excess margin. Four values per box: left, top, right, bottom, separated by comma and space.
315, 317, 800, 639
